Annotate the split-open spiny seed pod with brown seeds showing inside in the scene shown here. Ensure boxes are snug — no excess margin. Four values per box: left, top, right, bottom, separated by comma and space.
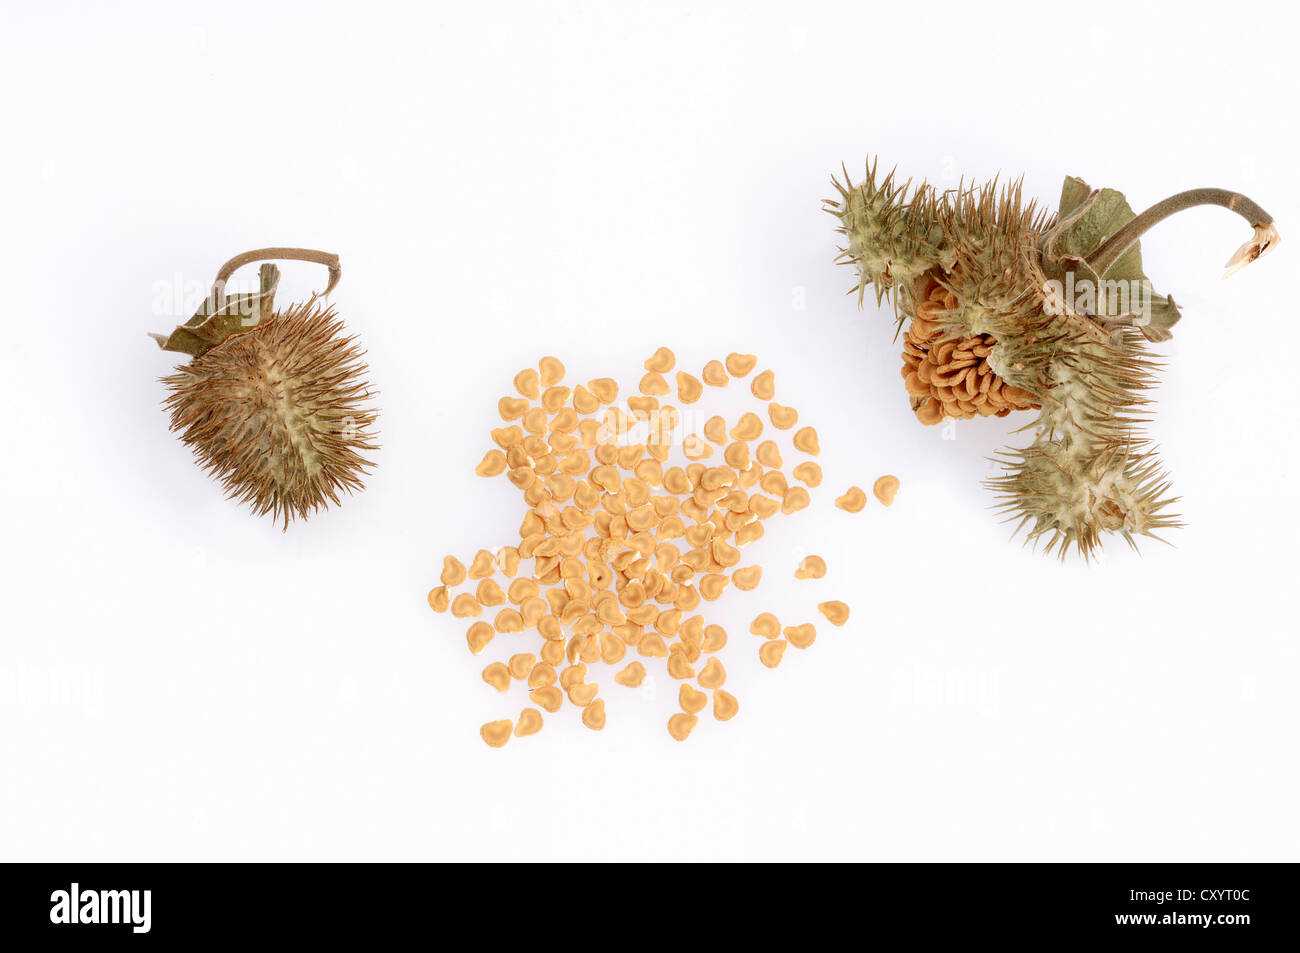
826, 158, 1278, 559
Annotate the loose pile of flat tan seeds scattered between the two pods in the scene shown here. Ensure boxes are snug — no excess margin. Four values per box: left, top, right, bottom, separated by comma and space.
429, 347, 897, 748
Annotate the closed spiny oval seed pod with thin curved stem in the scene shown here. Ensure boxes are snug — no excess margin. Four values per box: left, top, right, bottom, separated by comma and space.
152, 248, 376, 529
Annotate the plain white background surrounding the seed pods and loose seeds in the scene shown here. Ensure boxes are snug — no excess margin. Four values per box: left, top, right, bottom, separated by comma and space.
0, 0, 1300, 861
